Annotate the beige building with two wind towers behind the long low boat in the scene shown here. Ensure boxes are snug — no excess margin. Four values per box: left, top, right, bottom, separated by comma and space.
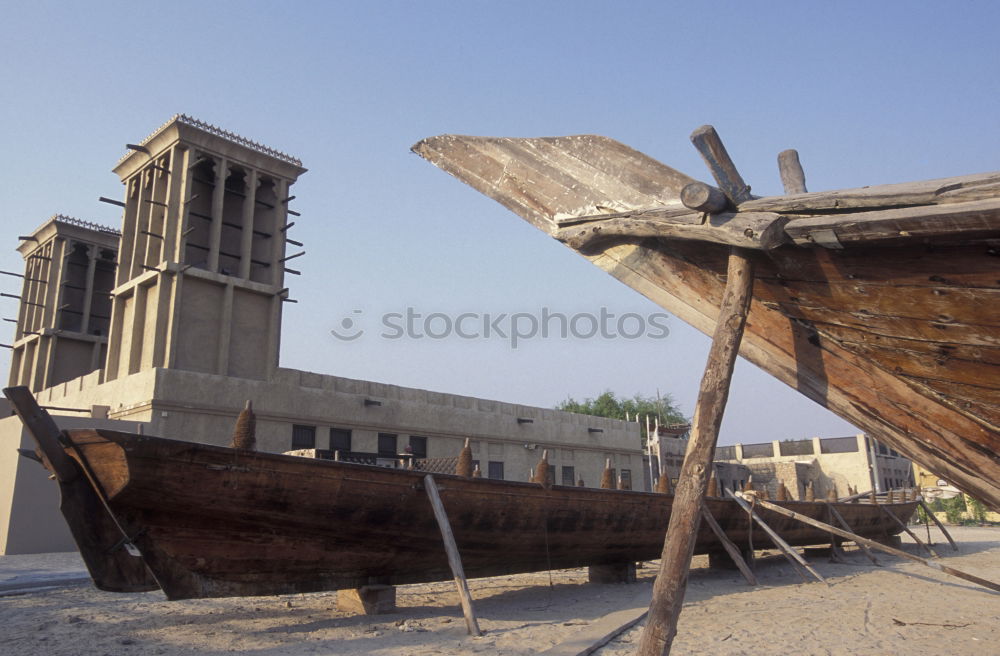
0, 115, 647, 553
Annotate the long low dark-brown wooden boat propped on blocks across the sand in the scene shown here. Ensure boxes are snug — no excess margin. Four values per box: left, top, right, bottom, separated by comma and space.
5, 387, 918, 599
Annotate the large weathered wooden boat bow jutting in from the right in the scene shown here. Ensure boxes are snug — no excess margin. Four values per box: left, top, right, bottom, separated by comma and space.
413, 131, 1000, 509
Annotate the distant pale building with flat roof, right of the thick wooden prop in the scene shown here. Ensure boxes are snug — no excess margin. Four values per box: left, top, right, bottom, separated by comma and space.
715, 433, 913, 499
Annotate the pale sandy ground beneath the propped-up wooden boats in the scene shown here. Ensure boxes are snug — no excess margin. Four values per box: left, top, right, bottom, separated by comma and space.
0, 528, 1000, 656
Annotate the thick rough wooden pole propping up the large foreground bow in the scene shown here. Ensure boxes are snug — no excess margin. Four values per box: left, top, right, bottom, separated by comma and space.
637, 248, 753, 656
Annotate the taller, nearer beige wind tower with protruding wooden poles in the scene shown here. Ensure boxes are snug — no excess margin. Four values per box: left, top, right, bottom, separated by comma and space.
102, 114, 306, 381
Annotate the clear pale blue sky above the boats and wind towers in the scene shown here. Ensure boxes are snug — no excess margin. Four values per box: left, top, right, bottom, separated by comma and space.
0, 0, 1000, 443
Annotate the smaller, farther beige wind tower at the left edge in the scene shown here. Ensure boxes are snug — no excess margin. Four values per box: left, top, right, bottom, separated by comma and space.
5, 214, 119, 392
